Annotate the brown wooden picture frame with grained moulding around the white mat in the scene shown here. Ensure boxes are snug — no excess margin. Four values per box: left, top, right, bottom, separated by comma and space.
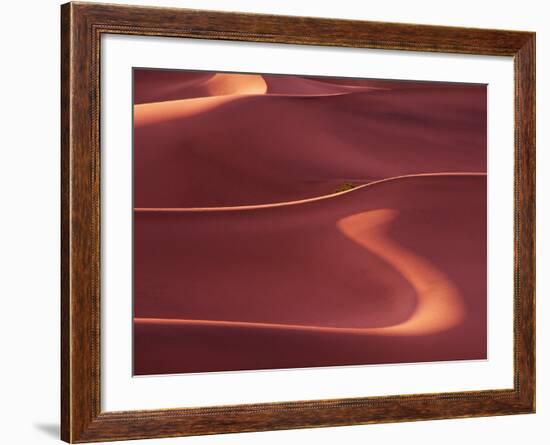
61, 3, 535, 443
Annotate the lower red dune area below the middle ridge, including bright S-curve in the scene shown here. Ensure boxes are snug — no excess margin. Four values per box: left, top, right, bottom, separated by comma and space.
134, 175, 486, 374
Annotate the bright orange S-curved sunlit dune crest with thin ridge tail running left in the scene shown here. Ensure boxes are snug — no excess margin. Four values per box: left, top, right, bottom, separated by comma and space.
134, 209, 464, 336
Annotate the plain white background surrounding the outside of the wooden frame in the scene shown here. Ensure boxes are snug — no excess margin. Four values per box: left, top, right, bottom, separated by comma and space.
0, 0, 550, 444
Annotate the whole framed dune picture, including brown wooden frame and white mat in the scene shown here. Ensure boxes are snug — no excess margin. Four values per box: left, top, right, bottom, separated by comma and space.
61, 3, 535, 443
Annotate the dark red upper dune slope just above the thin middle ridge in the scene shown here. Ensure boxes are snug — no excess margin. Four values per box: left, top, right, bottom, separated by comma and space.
134, 84, 486, 207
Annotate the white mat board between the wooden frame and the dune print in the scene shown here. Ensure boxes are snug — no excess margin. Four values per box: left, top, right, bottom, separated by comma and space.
101, 35, 514, 411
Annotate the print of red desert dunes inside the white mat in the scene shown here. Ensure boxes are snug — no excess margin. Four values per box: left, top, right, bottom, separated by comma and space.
133, 68, 487, 375
